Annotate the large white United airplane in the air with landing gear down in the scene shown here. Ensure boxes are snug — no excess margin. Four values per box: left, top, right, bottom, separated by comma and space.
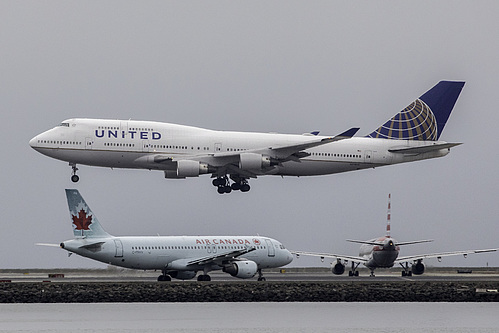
29, 81, 464, 194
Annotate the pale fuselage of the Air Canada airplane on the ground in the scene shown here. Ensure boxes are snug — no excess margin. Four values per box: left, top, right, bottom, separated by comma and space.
61, 236, 293, 271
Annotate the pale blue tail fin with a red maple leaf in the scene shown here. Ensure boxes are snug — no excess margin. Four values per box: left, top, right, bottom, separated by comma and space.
66, 189, 111, 238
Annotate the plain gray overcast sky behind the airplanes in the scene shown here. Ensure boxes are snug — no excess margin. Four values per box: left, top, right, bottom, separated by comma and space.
0, 1, 499, 268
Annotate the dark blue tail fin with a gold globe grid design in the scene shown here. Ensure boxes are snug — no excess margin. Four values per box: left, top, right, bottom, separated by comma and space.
367, 81, 464, 141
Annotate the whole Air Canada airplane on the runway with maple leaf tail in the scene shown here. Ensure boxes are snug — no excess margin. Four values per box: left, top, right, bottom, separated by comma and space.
38, 189, 293, 281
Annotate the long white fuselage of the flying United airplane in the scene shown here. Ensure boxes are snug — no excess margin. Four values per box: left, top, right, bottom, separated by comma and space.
30, 119, 449, 176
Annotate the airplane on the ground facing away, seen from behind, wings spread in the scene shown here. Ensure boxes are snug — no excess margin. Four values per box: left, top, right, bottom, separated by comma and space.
291, 195, 497, 276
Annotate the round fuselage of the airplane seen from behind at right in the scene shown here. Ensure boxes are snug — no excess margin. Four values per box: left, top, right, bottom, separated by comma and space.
359, 237, 400, 269
